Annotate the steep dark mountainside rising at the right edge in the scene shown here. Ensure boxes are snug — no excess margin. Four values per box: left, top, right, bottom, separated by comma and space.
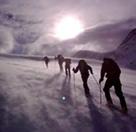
115, 29, 136, 69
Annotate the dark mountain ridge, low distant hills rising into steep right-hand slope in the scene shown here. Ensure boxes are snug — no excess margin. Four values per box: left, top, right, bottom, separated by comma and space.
74, 28, 136, 69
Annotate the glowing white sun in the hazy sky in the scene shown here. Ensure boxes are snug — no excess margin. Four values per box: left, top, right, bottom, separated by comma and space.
54, 16, 84, 40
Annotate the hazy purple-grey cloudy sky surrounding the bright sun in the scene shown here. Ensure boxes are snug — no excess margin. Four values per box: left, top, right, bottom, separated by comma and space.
0, 0, 136, 54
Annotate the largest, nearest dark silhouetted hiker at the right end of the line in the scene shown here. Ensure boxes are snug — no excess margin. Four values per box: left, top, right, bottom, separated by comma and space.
99, 58, 128, 113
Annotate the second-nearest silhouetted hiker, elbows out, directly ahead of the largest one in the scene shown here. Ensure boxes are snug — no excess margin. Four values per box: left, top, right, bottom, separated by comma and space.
73, 60, 93, 97
